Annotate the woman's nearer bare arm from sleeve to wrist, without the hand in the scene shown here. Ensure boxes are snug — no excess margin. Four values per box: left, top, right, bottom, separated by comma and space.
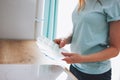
83, 20, 120, 62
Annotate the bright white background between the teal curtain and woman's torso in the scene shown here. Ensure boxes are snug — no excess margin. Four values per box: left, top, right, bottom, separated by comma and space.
56, 0, 78, 37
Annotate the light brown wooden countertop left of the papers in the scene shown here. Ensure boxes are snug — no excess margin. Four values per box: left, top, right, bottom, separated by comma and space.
0, 40, 54, 64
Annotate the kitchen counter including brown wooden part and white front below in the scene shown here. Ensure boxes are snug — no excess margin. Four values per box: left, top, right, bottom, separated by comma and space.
0, 40, 76, 80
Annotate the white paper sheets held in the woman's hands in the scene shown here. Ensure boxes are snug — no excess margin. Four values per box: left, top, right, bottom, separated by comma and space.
37, 36, 68, 60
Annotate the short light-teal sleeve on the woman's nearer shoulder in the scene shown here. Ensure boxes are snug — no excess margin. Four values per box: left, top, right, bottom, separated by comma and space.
105, 0, 120, 22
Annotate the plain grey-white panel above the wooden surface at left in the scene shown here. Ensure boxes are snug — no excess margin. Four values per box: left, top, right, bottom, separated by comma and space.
0, 0, 36, 39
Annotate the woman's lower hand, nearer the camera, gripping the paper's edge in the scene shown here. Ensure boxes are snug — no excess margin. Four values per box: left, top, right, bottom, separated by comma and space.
62, 52, 83, 64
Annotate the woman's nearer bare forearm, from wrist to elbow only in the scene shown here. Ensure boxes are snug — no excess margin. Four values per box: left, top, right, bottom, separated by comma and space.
80, 47, 119, 62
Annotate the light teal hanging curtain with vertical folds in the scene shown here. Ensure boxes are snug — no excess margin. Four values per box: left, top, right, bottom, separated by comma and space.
43, 0, 58, 40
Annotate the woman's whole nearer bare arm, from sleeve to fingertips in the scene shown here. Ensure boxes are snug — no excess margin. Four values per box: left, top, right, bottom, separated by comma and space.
62, 21, 120, 63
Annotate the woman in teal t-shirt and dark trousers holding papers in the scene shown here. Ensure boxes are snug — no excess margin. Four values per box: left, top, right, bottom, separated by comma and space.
54, 0, 120, 80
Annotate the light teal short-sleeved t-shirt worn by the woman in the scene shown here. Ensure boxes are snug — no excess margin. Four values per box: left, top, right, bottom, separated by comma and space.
71, 0, 120, 74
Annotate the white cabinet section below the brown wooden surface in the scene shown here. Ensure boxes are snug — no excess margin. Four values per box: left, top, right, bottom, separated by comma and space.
0, 64, 77, 80
